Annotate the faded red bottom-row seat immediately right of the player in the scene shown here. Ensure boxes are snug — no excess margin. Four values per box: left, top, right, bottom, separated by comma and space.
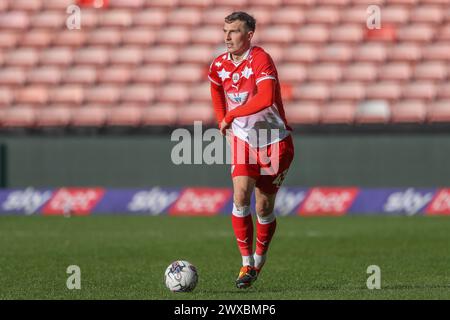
285, 101, 320, 125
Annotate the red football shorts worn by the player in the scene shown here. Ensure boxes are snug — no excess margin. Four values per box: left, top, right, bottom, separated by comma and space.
230, 135, 294, 194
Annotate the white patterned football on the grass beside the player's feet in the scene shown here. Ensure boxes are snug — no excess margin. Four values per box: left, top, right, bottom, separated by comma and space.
164, 260, 198, 292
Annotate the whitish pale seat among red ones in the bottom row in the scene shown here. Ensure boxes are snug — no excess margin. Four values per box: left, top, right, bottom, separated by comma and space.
355, 100, 391, 123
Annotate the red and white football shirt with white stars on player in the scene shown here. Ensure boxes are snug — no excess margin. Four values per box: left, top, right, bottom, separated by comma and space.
208, 47, 292, 147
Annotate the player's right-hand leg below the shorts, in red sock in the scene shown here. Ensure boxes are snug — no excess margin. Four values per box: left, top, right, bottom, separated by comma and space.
254, 187, 277, 272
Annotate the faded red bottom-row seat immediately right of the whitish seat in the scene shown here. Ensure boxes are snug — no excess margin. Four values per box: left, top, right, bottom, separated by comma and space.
391, 100, 427, 123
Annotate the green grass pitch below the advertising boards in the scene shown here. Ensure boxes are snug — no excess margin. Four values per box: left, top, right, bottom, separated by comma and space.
0, 216, 450, 300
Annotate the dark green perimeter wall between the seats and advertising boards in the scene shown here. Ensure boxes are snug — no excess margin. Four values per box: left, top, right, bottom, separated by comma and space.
0, 134, 450, 187
